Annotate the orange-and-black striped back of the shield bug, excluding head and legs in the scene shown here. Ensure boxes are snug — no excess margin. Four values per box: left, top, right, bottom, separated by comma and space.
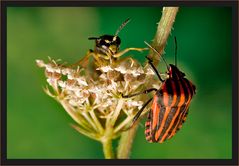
145, 78, 195, 143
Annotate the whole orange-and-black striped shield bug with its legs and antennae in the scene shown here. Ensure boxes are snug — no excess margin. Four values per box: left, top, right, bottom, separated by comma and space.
123, 38, 196, 143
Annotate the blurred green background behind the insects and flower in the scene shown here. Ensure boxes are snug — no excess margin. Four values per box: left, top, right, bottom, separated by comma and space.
7, 7, 232, 159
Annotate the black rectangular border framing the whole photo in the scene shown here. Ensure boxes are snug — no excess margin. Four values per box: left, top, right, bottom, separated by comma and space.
1, 1, 238, 165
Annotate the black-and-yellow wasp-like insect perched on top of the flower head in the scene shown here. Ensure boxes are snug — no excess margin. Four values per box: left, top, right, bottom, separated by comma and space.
73, 18, 148, 67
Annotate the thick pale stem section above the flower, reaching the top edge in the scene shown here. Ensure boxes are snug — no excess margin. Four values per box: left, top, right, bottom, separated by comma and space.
149, 7, 179, 65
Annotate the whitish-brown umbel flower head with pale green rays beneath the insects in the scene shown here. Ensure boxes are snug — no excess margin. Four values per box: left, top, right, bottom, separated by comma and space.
36, 58, 160, 141
